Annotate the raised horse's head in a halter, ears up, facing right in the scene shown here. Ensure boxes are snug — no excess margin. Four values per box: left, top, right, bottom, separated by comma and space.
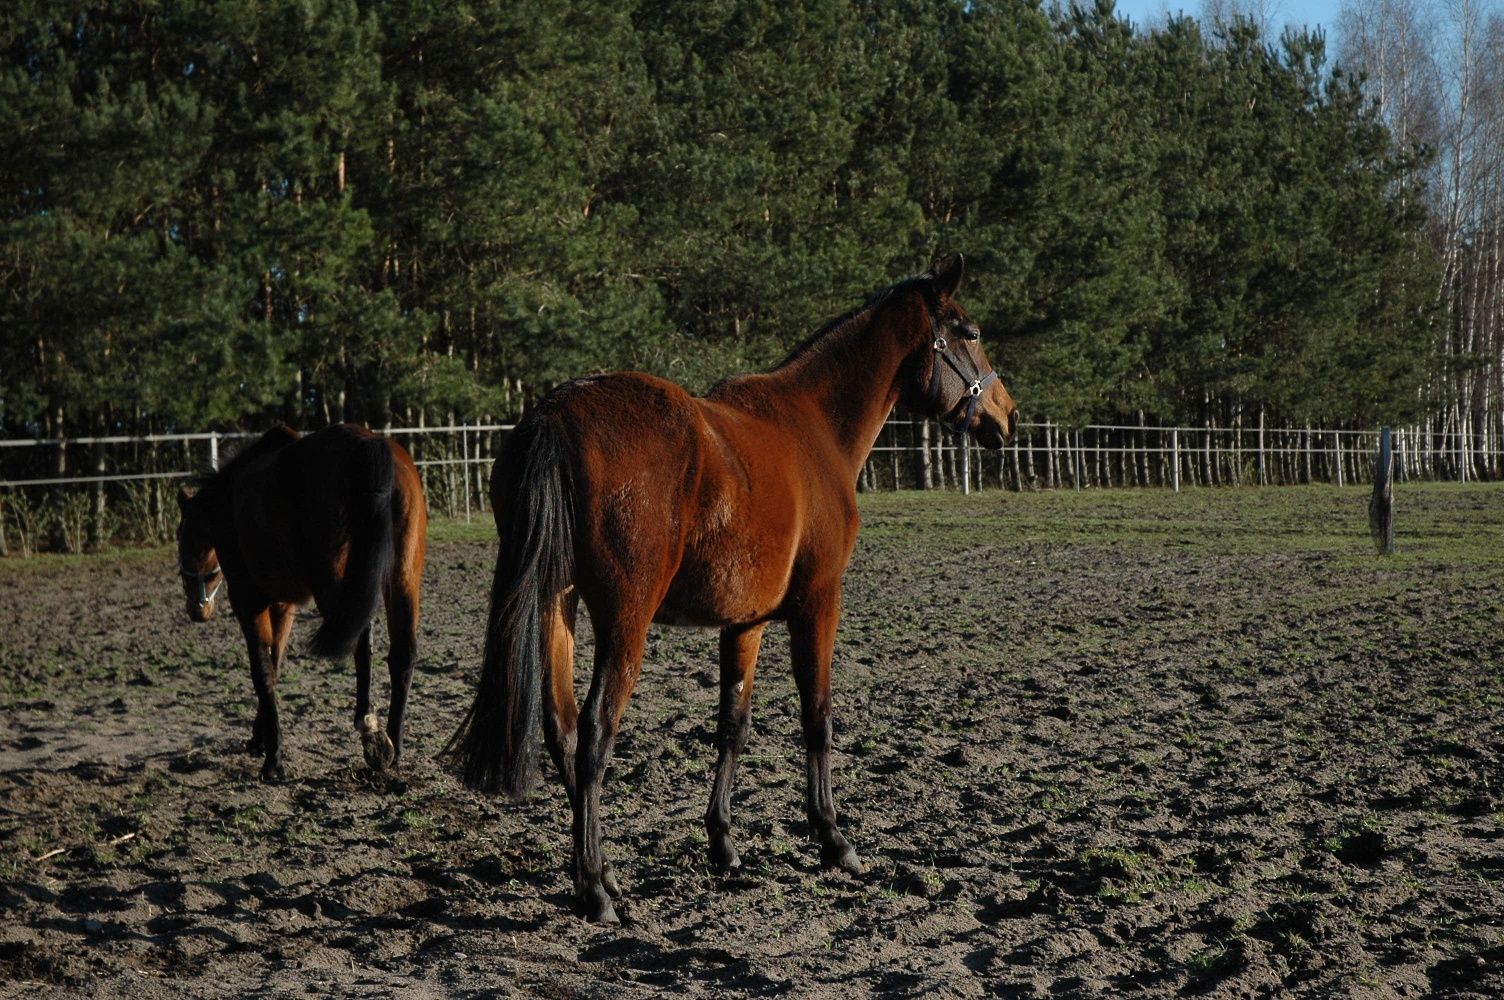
905, 254, 1018, 450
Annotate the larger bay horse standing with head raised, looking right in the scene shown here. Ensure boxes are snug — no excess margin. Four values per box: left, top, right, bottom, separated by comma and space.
447, 256, 1017, 923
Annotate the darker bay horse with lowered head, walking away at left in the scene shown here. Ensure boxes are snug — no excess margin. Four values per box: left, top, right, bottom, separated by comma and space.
177, 424, 429, 782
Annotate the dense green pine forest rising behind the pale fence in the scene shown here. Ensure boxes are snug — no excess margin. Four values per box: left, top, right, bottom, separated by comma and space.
0, 0, 1504, 460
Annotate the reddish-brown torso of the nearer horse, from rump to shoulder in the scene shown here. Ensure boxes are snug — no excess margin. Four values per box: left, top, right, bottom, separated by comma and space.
517, 373, 808, 626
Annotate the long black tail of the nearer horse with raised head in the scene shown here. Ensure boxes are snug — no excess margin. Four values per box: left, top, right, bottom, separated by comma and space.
444, 418, 575, 798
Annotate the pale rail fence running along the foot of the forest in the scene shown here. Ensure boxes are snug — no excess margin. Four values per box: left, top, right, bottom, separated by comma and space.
0, 418, 1504, 555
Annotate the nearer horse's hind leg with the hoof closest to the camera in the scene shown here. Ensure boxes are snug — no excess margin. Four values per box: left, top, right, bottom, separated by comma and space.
573, 614, 648, 923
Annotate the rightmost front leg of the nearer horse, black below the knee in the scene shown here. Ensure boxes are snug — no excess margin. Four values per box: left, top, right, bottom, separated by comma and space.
788, 588, 862, 875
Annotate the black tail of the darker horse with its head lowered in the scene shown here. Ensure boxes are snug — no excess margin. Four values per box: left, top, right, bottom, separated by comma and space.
308, 438, 396, 659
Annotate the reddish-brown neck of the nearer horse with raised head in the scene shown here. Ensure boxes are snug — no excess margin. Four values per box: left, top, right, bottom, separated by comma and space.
770, 304, 922, 481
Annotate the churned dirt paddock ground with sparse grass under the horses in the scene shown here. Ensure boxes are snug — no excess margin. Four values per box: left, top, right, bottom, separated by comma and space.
0, 486, 1504, 1000
